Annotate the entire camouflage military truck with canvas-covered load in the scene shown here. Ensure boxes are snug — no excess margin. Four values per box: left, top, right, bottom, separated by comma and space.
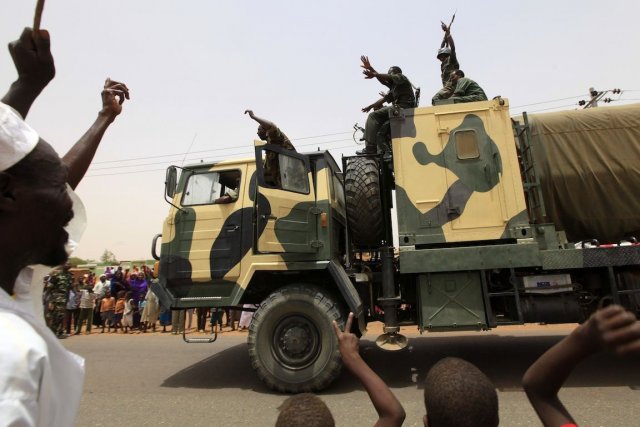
153, 98, 640, 393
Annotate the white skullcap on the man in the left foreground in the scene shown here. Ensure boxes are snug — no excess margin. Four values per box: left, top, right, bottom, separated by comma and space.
0, 102, 39, 172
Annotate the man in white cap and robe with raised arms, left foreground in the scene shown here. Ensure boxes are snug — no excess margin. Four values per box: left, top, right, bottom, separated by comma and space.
0, 28, 129, 426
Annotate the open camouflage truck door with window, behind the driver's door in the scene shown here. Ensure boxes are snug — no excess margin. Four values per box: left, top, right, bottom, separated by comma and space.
255, 145, 317, 253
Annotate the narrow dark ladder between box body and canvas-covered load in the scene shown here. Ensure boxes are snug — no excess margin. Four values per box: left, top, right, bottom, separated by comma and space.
512, 112, 547, 224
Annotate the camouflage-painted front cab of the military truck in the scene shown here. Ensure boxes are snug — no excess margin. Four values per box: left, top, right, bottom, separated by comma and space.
154, 150, 364, 327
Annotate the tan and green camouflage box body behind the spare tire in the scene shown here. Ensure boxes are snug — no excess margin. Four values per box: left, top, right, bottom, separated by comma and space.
391, 99, 528, 246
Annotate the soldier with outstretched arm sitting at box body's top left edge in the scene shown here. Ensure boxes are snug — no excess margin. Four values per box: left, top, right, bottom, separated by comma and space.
357, 56, 416, 154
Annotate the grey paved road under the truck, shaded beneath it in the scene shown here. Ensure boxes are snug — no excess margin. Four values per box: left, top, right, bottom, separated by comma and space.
64, 327, 640, 427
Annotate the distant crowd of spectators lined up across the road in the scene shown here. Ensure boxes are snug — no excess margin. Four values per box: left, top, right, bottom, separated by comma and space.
43, 263, 255, 338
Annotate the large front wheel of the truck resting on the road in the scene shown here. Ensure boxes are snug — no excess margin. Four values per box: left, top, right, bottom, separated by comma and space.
247, 285, 343, 393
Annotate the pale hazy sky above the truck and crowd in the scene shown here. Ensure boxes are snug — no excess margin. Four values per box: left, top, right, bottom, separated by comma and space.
0, 0, 640, 260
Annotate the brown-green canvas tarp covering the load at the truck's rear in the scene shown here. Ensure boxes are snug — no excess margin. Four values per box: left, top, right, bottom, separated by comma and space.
529, 104, 640, 243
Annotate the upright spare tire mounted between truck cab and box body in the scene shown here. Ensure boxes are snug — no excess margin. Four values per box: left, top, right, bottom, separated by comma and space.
344, 157, 384, 247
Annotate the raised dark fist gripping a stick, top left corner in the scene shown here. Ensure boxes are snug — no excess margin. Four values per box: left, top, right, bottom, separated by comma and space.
9, 28, 56, 89
